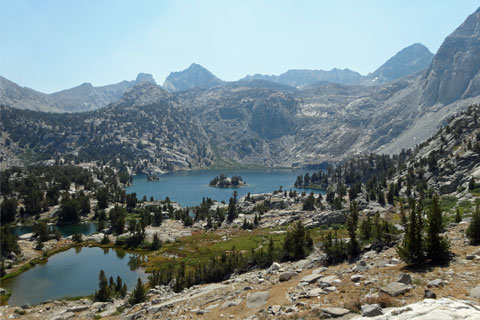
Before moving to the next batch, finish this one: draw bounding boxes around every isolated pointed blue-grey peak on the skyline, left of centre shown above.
[163,63,223,92]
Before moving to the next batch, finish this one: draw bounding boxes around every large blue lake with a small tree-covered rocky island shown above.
[127,169,323,206]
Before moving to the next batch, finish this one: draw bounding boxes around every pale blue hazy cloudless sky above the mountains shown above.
[0,0,479,93]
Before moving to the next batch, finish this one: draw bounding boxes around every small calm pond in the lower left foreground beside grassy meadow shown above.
[2,248,147,306]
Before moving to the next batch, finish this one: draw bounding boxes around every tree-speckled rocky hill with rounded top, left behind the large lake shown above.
[0,82,213,172]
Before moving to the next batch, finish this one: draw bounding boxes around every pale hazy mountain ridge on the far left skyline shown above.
[0,73,155,112]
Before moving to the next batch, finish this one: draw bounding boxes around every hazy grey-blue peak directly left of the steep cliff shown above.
[363,43,433,85]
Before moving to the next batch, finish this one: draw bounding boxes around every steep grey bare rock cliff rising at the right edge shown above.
[422,8,480,106]
